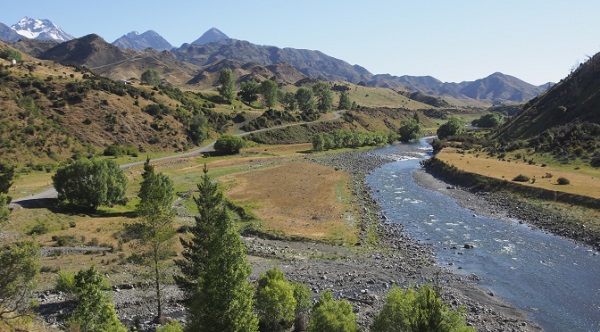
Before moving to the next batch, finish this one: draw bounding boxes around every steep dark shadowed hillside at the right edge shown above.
[496,53,600,167]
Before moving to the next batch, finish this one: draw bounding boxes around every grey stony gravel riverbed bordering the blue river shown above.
[38,152,541,331]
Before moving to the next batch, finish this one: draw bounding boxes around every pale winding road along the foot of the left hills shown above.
[9,111,344,208]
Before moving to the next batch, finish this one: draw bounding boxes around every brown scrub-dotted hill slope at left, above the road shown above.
[0,43,221,165]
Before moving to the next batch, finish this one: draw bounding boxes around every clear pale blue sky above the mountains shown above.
[0,0,600,85]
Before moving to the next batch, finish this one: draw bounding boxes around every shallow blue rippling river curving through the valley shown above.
[367,140,600,331]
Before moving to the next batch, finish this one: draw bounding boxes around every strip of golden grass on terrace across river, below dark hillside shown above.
[436,148,600,198]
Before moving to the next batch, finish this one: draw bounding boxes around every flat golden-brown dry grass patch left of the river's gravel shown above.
[221,162,357,243]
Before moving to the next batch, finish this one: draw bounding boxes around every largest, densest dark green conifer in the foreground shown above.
[175,165,258,332]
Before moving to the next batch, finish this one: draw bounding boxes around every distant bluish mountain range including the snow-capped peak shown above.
[0,18,552,104]
